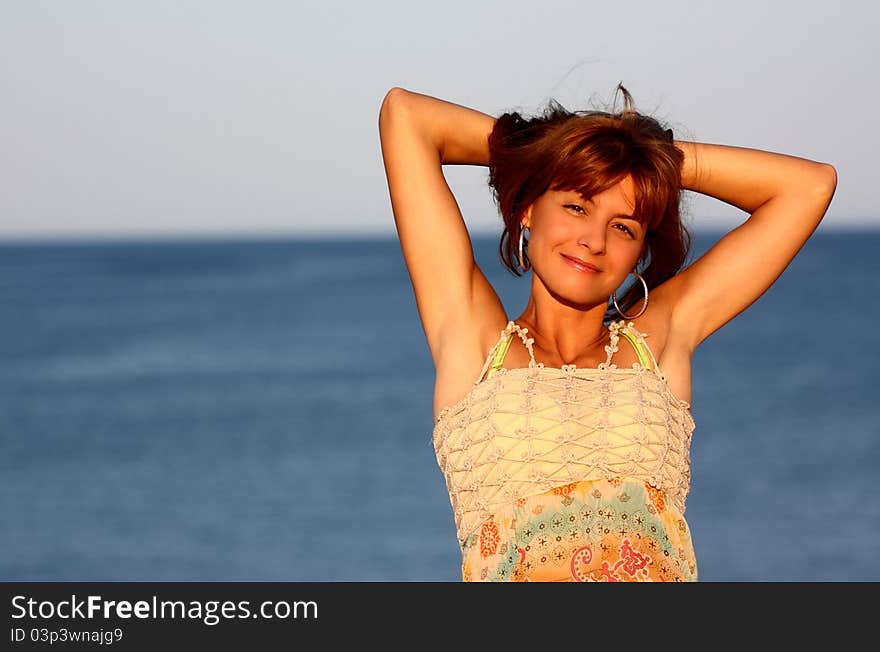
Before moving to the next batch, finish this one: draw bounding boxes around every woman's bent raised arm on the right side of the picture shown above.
[667,141,837,351]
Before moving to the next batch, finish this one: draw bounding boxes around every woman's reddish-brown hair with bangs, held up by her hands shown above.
[489,84,691,319]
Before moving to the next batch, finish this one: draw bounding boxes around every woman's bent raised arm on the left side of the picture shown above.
[379,88,504,367]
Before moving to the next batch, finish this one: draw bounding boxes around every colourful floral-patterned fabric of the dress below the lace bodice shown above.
[462,477,697,582]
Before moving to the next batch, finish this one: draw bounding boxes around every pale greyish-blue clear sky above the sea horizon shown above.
[0,0,880,239]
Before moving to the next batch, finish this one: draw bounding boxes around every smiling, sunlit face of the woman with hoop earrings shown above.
[523,176,645,306]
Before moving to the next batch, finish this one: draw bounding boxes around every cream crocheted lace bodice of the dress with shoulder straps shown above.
[433,321,695,542]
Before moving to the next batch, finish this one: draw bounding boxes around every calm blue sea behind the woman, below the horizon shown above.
[0,230,880,582]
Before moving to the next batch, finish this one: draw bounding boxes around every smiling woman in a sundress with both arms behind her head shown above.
[379,85,837,581]
